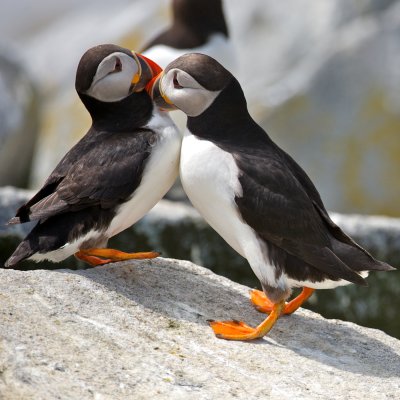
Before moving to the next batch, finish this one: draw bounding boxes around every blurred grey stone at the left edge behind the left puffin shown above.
[0,46,39,186]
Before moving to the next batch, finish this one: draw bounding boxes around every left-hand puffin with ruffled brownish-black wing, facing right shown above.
[5,44,181,267]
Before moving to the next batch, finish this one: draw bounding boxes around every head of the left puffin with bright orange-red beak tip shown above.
[75,44,161,103]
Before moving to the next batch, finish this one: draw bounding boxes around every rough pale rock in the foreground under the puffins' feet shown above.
[0,258,400,400]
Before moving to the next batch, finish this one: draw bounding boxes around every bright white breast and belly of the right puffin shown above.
[180,131,286,287]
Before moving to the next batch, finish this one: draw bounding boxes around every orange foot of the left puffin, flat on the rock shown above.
[75,249,160,266]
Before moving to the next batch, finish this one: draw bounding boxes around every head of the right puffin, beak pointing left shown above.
[146,53,234,117]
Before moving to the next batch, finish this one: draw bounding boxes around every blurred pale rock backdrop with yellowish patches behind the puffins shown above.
[0,0,400,216]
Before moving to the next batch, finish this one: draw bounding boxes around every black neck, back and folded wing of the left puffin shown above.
[16,91,155,222]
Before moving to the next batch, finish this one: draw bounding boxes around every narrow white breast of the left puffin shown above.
[107,109,182,237]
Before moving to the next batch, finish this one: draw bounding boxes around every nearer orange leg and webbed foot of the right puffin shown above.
[208,301,285,340]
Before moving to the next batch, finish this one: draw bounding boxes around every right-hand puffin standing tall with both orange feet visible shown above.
[146,53,394,340]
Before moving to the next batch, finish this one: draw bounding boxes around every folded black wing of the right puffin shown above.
[234,143,365,284]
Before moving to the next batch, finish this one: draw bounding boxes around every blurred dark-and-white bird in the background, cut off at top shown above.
[140,0,236,70]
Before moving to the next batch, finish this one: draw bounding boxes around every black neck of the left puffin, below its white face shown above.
[78,90,153,132]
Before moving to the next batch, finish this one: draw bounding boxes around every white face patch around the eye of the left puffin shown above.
[86,52,139,102]
